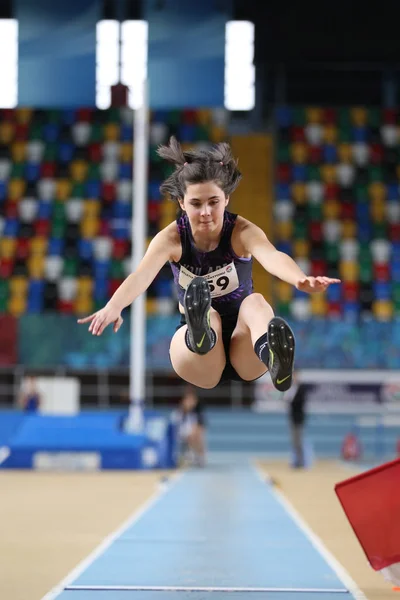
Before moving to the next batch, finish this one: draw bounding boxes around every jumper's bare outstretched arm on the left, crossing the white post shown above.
[78,226,174,335]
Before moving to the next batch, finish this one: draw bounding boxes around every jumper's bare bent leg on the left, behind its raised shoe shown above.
[169,308,225,389]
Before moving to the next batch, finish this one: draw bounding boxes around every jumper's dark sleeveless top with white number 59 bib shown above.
[170,211,253,316]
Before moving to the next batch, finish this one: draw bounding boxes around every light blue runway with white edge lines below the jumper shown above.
[43,465,364,600]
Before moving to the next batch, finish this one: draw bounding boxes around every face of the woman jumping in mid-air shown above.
[180,181,229,232]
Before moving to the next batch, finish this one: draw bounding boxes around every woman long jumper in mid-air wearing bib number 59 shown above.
[78,137,340,392]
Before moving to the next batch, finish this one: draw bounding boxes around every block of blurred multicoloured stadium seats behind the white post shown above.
[0,108,226,316]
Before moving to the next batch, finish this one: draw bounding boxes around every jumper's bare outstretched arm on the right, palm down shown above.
[240,222,340,293]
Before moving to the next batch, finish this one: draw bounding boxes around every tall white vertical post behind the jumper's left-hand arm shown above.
[126,81,149,432]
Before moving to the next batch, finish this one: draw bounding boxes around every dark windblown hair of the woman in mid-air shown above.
[157,136,242,201]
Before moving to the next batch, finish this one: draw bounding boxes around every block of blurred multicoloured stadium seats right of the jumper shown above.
[275,106,400,321]
